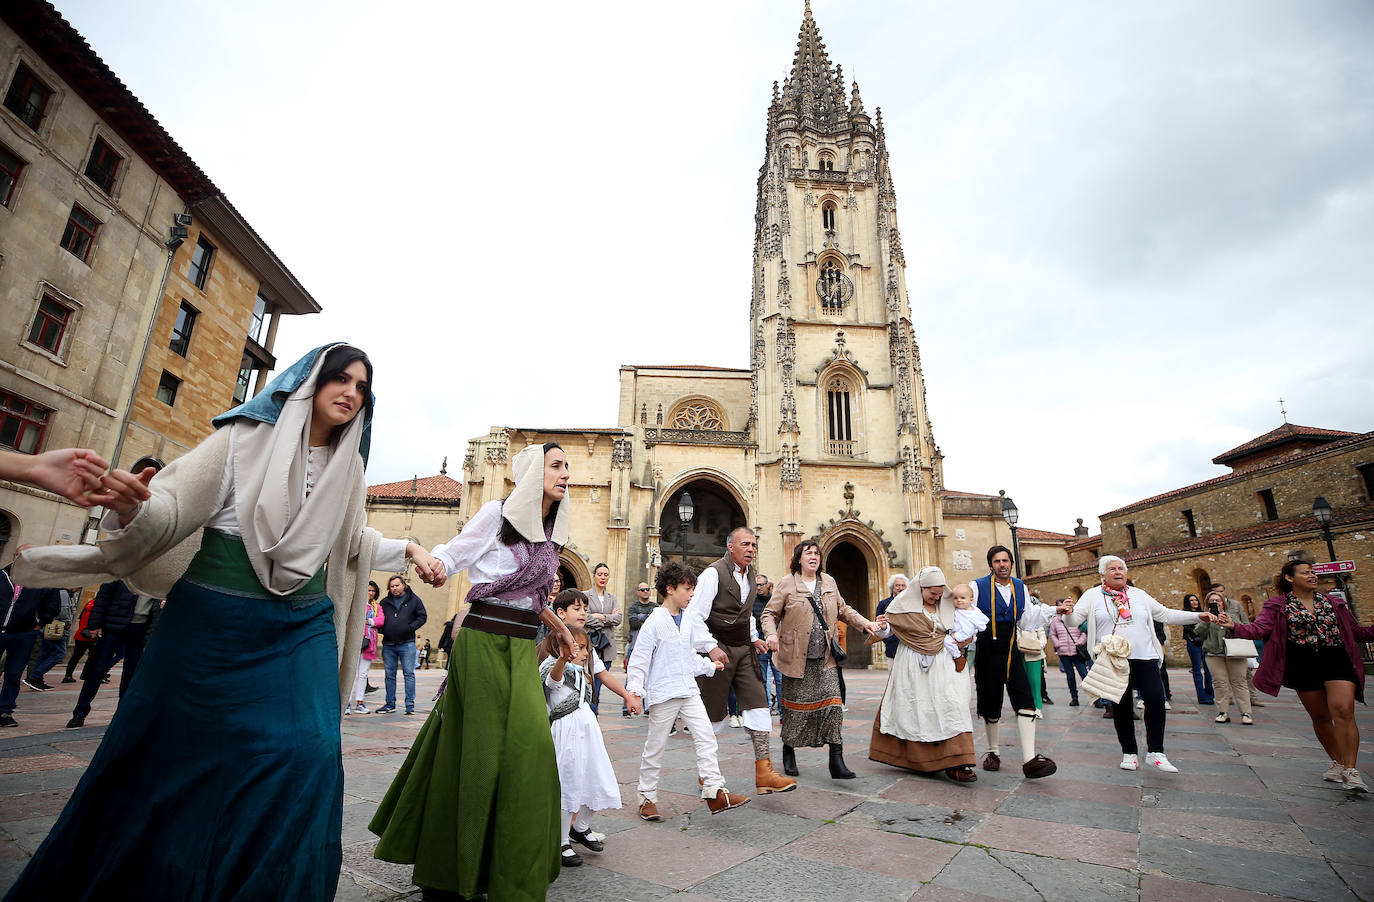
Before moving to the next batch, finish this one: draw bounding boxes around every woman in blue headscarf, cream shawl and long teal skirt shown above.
[5,344,442,901]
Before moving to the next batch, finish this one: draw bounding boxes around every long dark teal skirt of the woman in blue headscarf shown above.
[5,579,344,902]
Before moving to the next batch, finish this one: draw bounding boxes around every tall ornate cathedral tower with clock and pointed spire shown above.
[750,1,943,585]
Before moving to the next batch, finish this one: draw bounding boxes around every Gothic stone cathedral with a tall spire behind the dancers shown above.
[370,3,1073,666]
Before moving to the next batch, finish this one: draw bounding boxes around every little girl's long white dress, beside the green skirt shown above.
[539,656,620,811]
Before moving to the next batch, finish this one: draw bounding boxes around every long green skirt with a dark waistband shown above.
[368,630,563,902]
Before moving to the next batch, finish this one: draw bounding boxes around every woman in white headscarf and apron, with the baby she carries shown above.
[868,567,988,782]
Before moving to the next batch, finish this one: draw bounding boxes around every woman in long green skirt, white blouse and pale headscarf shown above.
[371,441,573,902]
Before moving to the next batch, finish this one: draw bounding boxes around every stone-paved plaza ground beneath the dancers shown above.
[0,670,1374,902]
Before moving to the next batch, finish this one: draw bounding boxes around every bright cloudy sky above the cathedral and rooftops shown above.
[50,0,1374,532]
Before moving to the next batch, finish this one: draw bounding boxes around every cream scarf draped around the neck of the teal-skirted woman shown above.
[229,352,365,595]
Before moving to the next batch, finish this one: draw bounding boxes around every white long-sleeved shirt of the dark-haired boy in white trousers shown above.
[625,602,716,705]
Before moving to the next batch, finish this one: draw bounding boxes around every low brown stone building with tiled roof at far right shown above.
[1028,424,1374,663]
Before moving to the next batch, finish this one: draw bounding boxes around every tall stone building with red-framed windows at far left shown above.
[0,0,320,554]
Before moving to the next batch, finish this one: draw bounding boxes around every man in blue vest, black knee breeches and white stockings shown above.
[973,545,1073,778]
